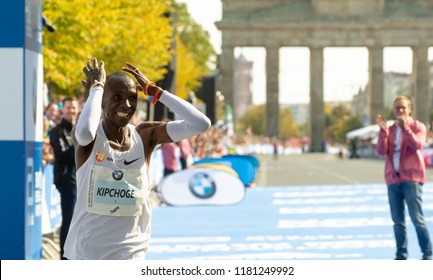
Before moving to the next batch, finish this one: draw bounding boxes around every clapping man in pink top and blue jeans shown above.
[376,96,432,260]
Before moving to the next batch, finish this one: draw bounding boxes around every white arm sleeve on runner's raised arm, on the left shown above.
[75,86,104,146]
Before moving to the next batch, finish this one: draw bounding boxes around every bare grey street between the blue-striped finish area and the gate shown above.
[251,153,433,186]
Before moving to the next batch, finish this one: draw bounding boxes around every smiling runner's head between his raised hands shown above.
[102,72,138,127]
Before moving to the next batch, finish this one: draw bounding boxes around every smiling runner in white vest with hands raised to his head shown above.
[65,58,210,260]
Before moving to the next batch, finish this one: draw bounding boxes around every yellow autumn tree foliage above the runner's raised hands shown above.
[43,0,216,103]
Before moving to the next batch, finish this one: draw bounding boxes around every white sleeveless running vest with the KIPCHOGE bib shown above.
[65,122,151,260]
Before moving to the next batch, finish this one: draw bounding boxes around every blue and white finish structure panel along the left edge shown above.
[0,0,43,260]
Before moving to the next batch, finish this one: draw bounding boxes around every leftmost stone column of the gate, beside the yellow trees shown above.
[219,46,236,116]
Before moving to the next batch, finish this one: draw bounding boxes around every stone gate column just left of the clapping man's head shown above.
[368,46,384,123]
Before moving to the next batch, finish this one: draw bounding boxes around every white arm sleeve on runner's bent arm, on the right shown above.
[159,90,211,142]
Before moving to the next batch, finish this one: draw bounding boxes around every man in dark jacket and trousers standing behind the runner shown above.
[50,97,78,259]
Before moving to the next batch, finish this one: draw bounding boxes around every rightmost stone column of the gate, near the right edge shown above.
[412,46,430,125]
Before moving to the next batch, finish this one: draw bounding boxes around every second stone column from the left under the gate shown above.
[266,46,280,137]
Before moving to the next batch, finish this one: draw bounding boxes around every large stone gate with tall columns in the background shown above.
[216,0,433,152]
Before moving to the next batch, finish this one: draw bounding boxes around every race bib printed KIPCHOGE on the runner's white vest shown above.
[87,165,143,216]
